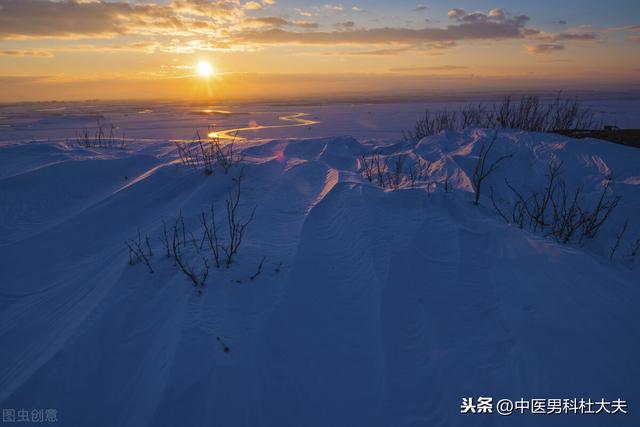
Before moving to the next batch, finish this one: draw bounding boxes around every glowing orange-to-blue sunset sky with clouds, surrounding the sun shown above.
[0,0,640,102]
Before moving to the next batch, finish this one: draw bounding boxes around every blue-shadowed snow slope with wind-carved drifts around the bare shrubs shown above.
[0,129,640,426]
